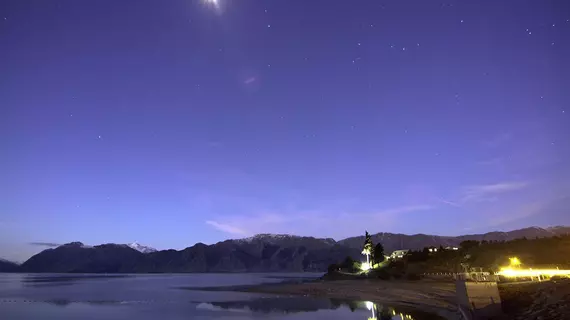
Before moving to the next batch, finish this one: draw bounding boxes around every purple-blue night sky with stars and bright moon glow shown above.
[0,0,570,261]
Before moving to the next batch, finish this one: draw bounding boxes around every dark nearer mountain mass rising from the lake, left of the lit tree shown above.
[20,235,352,273]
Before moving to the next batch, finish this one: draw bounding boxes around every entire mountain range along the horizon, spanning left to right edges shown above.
[0,227,570,273]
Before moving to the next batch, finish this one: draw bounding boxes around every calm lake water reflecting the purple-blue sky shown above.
[0,274,440,320]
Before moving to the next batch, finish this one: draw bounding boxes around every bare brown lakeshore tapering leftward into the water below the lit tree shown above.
[180,279,457,319]
